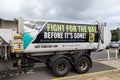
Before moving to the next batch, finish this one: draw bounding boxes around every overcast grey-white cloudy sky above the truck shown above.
[0,0,120,29]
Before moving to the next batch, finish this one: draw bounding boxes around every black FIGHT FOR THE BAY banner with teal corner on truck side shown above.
[23,20,99,50]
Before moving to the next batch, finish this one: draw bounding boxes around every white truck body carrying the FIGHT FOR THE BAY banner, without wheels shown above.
[0,19,111,53]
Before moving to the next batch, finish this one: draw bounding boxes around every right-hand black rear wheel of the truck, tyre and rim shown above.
[75,56,90,74]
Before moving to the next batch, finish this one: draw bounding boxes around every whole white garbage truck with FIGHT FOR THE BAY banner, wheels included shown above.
[0,17,111,77]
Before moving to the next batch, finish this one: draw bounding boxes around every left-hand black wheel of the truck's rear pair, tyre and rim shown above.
[52,58,71,77]
